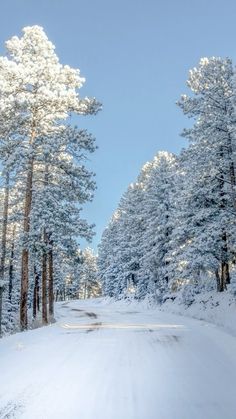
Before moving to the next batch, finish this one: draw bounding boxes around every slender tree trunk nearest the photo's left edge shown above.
[0,173,9,336]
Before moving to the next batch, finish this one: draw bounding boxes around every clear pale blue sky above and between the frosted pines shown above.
[0,0,236,247]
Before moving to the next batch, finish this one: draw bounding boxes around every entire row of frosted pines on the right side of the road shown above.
[99,57,236,305]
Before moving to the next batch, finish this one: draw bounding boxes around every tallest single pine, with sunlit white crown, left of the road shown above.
[0,26,101,330]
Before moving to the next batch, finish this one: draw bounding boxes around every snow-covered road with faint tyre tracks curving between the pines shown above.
[0,300,236,419]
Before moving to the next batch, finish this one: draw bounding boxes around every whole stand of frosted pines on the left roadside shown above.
[0,26,100,329]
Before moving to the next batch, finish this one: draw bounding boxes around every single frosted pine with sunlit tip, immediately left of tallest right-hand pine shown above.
[139,152,177,299]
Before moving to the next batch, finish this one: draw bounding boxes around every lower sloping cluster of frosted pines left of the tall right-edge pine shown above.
[98,152,176,298]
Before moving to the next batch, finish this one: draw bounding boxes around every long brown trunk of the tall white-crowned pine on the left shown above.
[20,159,34,330]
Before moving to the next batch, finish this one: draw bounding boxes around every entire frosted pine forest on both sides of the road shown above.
[0,26,236,342]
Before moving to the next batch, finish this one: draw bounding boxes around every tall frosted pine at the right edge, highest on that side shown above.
[179,57,236,291]
